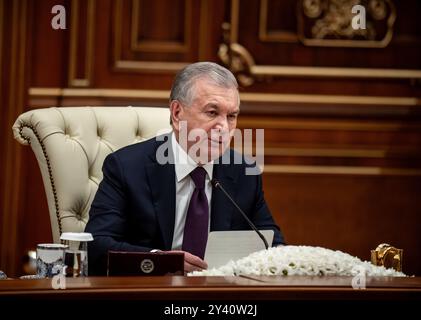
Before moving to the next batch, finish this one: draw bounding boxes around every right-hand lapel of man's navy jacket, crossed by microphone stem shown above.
[210,164,237,231]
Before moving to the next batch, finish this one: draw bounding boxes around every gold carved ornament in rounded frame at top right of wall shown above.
[297,0,396,48]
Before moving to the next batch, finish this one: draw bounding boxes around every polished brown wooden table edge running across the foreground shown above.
[0,276,421,300]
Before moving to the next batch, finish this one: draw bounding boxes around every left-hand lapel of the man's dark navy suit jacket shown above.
[147,135,175,250]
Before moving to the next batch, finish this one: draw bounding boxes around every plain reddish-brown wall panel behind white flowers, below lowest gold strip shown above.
[264,172,421,275]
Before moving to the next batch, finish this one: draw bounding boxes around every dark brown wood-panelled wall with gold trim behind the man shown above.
[0,0,421,275]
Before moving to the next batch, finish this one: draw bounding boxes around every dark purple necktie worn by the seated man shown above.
[182,167,209,259]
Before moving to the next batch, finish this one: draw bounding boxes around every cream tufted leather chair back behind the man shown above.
[13,107,170,243]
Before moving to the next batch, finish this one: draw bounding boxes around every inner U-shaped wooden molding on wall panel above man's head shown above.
[131,0,192,53]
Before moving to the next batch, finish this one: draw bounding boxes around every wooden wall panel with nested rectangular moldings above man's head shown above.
[90,0,223,90]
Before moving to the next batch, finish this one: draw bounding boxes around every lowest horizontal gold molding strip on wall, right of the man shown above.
[263,164,421,176]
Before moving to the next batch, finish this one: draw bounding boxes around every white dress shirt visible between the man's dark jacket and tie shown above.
[171,132,213,250]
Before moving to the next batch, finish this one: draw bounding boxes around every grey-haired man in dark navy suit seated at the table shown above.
[86,62,284,274]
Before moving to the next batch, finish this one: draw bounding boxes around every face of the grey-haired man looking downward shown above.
[170,79,240,163]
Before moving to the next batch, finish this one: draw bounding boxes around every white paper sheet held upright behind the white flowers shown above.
[205,230,274,269]
